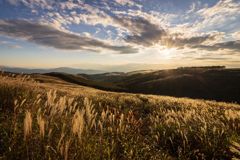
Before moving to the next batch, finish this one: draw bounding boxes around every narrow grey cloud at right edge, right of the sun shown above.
[190,40,240,53]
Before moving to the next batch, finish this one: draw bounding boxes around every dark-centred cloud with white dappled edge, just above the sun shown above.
[62,11,174,47]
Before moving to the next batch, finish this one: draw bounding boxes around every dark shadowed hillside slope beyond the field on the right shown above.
[80,68,240,103]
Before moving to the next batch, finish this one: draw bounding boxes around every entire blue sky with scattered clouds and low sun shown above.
[0,0,240,72]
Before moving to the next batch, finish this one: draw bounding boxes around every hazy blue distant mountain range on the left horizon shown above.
[2,66,106,74]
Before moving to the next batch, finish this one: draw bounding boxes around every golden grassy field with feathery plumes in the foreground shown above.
[0,69,240,160]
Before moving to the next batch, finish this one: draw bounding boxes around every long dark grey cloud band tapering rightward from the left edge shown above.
[0,20,138,54]
